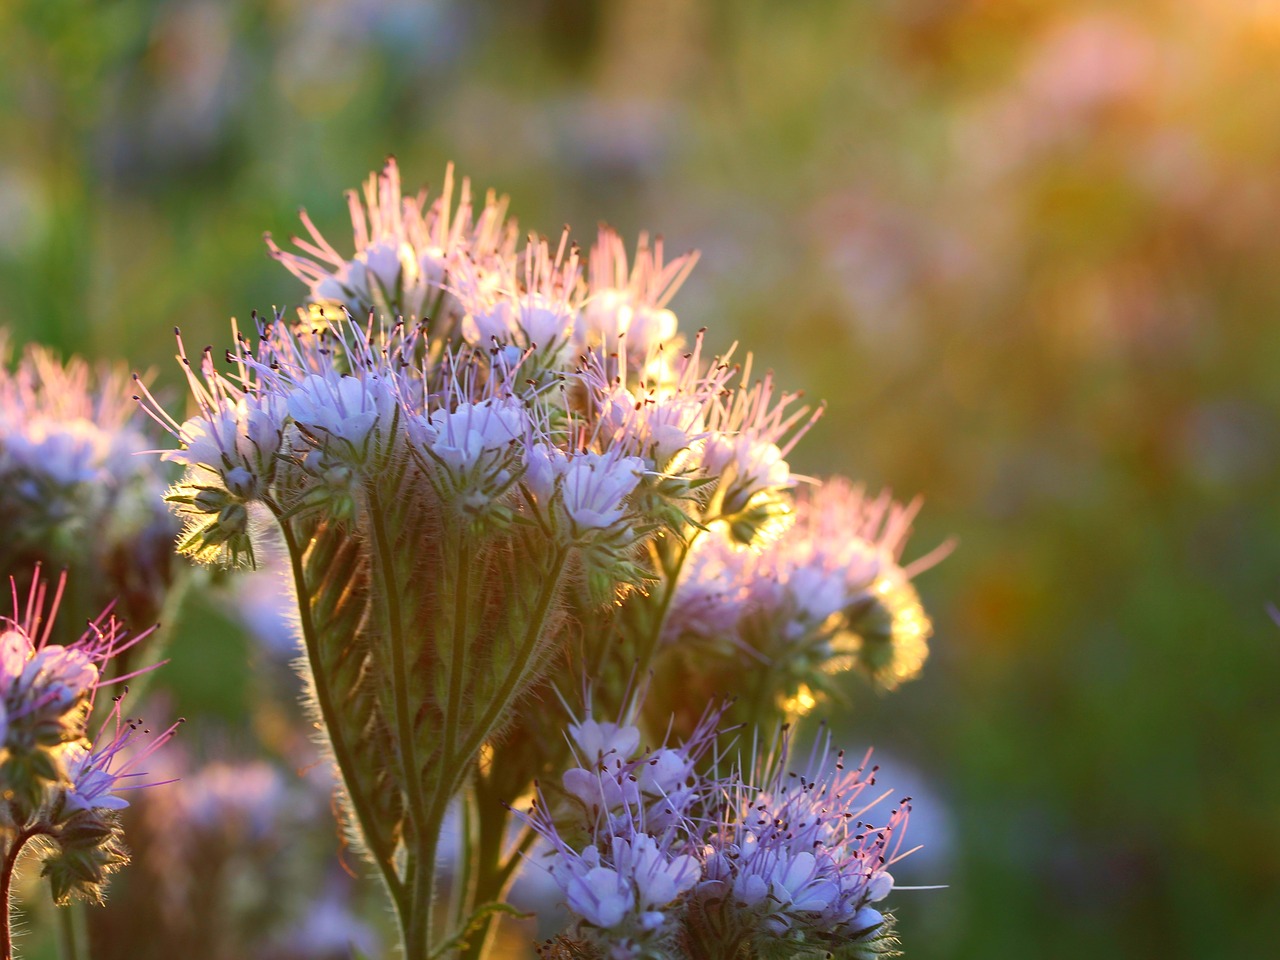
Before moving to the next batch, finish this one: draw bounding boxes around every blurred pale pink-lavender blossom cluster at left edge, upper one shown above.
[0,332,177,639]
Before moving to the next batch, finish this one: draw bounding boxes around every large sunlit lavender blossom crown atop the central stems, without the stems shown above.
[137,163,812,580]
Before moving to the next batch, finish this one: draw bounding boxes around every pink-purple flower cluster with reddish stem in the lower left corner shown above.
[0,571,177,915]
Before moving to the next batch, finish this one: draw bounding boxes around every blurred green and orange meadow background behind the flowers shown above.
[0,0,1280,960]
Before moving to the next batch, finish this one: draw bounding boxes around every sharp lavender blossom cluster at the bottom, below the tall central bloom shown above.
[521,712,911,960]
